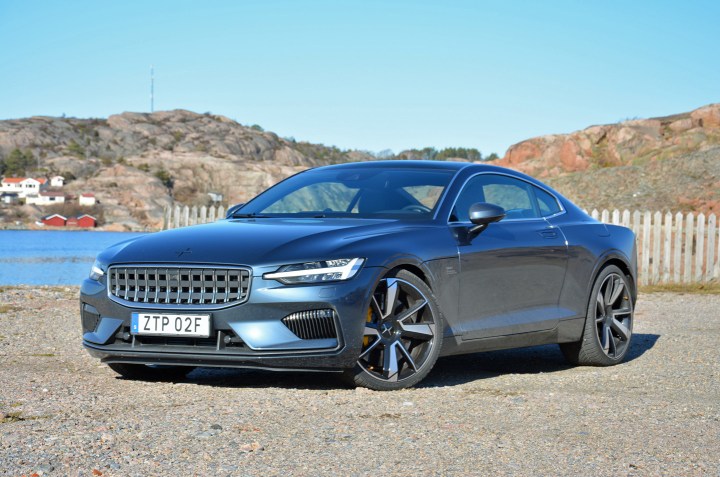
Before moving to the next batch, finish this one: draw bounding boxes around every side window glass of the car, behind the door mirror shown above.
[450,174,561,222]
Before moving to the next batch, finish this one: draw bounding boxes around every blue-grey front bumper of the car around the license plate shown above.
[80,267,384,371]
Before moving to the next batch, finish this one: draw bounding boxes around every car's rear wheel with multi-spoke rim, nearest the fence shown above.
[560,265,634,366]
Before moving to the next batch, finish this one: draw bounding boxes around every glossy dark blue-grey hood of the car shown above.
[98,218,430,267]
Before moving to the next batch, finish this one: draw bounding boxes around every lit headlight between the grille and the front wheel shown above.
[263,258,365,285]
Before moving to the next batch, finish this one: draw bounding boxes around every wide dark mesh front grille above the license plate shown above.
[108,266,250,305]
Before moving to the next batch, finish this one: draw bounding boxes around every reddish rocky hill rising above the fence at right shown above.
[495,104,720,214]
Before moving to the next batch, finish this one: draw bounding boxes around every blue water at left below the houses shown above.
[0,230,143,285]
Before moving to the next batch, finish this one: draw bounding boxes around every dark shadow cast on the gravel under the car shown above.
[179,333,660,391]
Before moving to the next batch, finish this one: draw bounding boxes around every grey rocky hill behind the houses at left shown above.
[0,110,371,230]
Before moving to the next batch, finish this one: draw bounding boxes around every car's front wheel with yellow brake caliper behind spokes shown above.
[344,270,443,391]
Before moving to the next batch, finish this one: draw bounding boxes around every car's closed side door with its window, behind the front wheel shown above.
[450,173,568,340]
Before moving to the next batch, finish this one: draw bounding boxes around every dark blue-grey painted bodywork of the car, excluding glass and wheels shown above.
[81,161,636,370]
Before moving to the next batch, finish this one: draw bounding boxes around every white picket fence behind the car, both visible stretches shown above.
[163,205,720,285]
